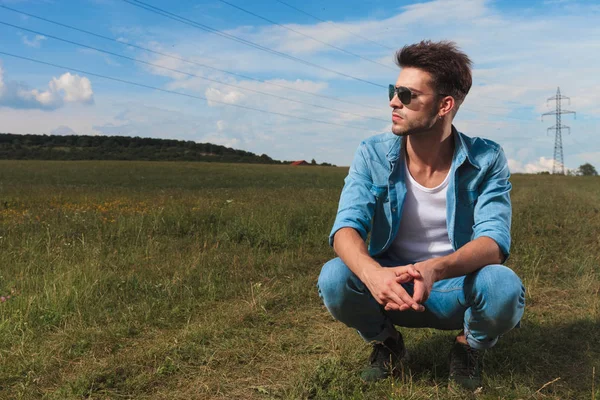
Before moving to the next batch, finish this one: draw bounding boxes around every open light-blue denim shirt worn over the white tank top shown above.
[329,126,512,258]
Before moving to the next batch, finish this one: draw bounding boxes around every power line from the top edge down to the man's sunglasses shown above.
[123,0,387,88]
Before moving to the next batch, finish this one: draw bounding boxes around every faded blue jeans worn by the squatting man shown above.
[318,258,525,349]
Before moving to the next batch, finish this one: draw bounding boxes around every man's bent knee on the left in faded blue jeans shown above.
[317,257,366,319]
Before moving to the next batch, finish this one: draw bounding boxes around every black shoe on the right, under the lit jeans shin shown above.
[449,342,484,390]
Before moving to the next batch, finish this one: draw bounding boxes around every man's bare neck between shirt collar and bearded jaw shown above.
[405,121,454,177]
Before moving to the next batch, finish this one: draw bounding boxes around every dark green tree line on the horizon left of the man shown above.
[0,133,330,165]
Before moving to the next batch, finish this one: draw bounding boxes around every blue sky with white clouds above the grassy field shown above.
[0,0,600,172]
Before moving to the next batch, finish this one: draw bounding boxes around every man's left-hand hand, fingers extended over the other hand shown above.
[362,265,425,311]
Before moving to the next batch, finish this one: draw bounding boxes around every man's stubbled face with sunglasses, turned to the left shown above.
[390,68,439,136]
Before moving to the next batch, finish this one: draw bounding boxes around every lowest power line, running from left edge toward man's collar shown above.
[0,51,382,131]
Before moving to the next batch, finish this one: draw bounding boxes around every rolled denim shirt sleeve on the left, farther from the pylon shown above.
[329,143,376,246]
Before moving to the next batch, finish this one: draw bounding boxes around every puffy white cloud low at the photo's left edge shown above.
[0,64,94,110]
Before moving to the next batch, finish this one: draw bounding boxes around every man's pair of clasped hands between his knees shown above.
[364,260,436,312]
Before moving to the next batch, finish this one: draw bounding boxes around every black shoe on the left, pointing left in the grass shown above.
[360,332,407,382]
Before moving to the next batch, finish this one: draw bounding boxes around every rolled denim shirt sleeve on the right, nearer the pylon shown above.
[473,148,512,259]
